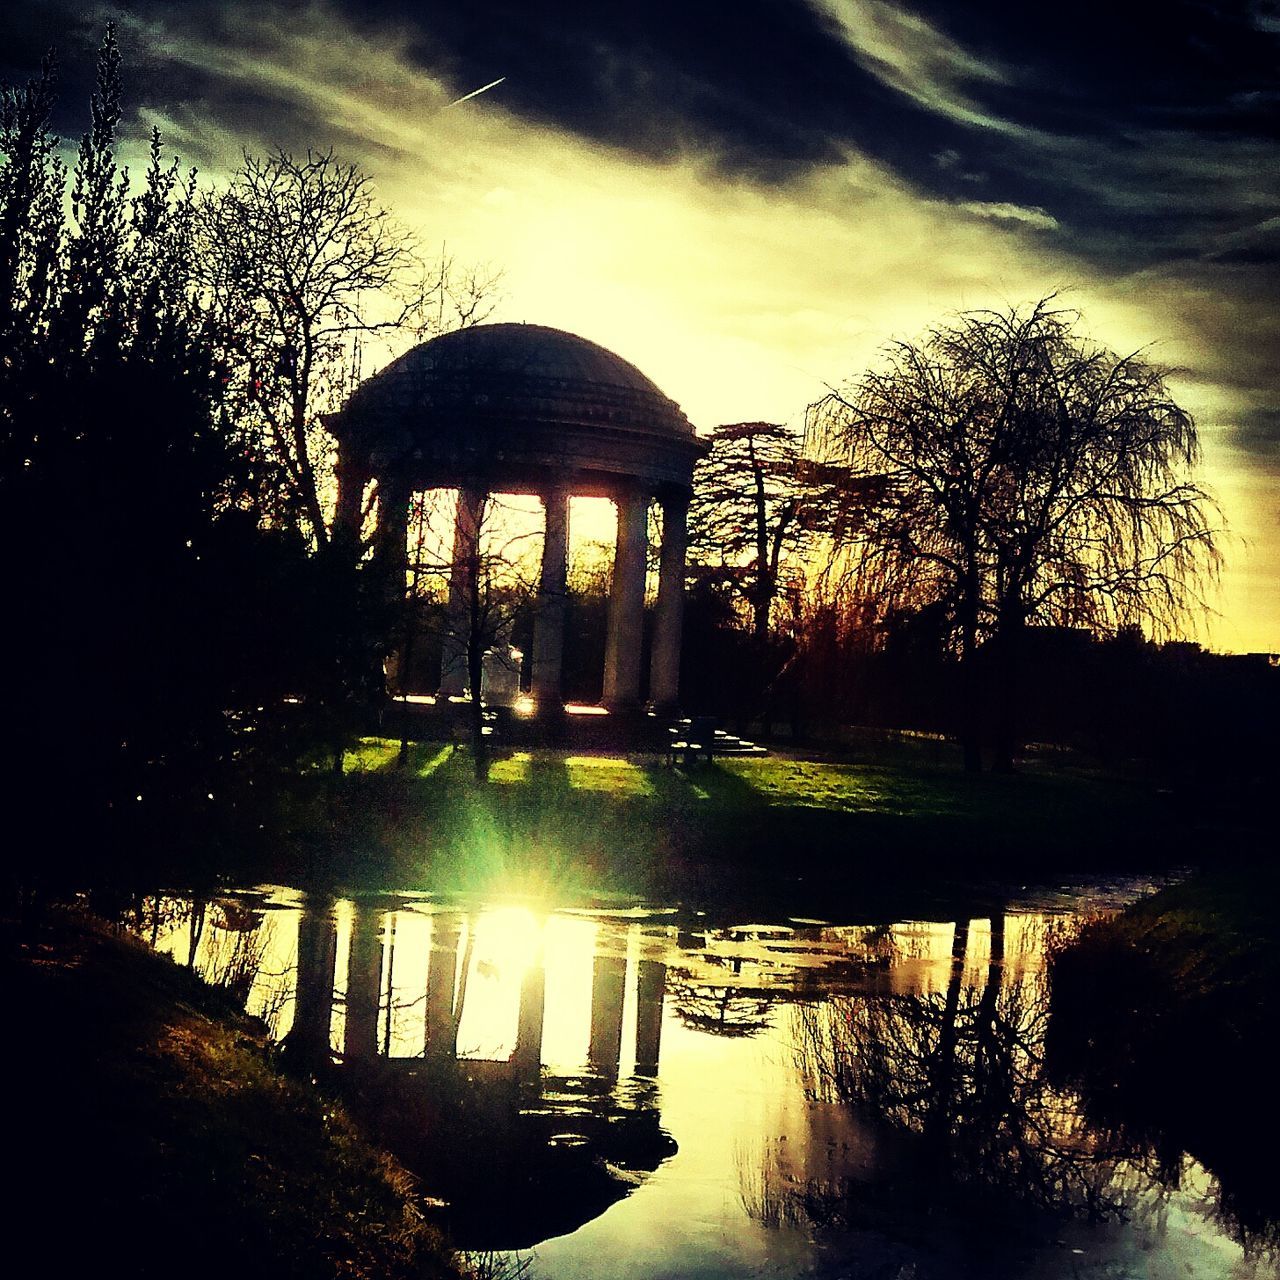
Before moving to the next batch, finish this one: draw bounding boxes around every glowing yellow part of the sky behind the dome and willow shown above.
[15,0,1280,650]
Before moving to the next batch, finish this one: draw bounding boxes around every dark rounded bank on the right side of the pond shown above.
[1047,865,1280,1256]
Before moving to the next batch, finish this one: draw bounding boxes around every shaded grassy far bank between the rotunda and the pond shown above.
[24,739,1223,914]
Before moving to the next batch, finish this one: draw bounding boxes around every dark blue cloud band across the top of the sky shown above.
[8,0,1280,269]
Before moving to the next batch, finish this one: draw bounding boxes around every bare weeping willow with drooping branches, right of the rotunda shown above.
[812,297,1221,769]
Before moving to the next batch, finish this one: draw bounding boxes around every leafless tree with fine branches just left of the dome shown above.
[200,150,498,545]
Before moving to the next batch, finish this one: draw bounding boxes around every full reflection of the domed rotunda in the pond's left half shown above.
[137,891,676,1249]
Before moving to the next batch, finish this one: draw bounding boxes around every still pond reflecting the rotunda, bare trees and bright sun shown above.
[133,882,1277,1280]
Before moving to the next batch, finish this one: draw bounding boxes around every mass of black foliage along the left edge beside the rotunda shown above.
[0,29,378,864]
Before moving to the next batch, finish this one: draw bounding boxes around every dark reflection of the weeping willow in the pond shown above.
[768,914,1161,1242]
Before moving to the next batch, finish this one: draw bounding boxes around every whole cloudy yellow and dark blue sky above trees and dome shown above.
[10,0,1280,650]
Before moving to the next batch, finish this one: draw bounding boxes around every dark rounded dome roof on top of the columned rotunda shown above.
[343,324,694,438]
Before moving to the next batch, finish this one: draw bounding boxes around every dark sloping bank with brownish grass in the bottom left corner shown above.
[0,909,461,1280]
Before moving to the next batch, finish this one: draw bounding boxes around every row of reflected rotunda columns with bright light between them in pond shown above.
[280,897,668,1085]
